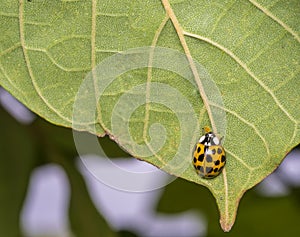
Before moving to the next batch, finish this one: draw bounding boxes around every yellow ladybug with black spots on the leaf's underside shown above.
[193,127,226,179]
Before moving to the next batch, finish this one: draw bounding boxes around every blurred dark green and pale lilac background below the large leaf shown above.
[0,88,300,237]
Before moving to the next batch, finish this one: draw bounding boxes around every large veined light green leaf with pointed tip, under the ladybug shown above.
[0,0,300,231]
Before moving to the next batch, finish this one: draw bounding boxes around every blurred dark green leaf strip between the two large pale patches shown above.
[32,120,115,237]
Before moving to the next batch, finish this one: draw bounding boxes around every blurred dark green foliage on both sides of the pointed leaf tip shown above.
[157,179,300,237]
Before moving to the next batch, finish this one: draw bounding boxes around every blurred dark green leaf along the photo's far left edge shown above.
[0,106,37,237]
